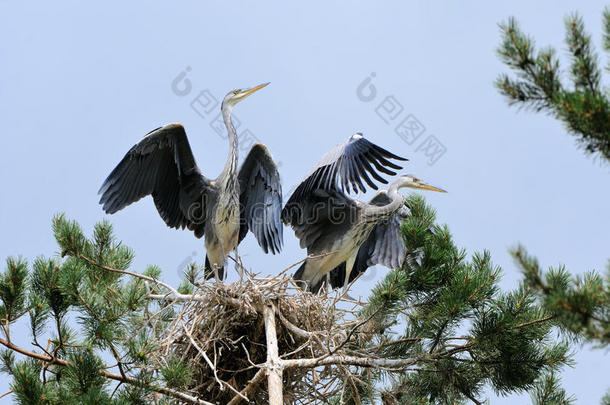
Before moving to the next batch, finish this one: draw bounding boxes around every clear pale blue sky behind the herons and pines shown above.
[0,0,610,404]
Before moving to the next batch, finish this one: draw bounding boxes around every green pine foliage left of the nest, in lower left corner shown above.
[0,215,178,405]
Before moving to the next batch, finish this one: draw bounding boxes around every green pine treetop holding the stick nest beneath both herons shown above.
[0,195,580,404]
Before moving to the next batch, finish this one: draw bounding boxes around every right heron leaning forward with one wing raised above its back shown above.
[282,134,444,292]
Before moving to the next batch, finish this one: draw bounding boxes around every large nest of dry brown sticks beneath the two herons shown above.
[159,266,362,404]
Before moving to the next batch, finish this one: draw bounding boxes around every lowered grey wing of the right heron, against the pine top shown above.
[330,192,409,288]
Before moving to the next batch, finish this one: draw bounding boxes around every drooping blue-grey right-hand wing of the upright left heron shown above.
[238,143,283,254]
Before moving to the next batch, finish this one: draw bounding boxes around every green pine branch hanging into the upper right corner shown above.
[495,8,610,161]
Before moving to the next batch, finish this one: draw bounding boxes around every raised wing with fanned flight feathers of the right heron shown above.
[282,134,407,224]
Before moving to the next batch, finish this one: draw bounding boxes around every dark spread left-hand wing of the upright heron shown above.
[98,124,213,238]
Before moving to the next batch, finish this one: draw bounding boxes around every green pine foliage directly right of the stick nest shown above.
[338,195,570,404]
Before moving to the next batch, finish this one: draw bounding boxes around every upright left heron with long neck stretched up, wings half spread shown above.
[99,83,283,280]
